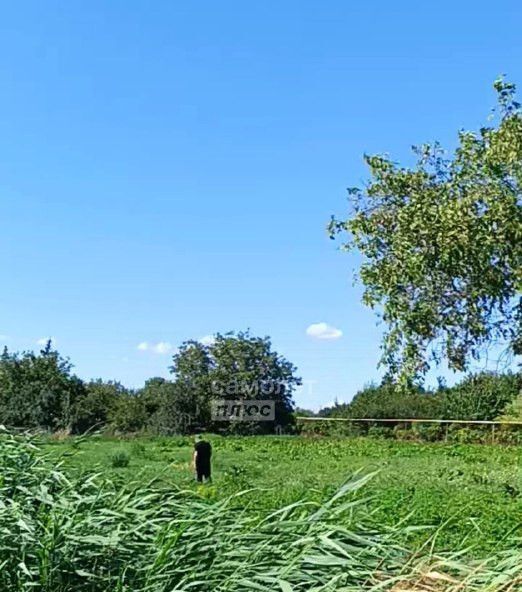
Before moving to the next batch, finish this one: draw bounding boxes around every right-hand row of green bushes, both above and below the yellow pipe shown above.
[298,372,522,444]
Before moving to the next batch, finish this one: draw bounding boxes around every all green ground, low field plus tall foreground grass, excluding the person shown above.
[0,432,522,592]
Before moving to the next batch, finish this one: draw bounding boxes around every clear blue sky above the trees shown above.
[0,0,522,407]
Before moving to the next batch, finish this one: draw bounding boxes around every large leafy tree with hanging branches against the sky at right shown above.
[329,79,522,382]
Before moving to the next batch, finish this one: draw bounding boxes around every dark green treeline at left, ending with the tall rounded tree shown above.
[0,332,301,434]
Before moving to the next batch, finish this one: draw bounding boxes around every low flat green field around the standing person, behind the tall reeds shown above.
[44,436,522,557]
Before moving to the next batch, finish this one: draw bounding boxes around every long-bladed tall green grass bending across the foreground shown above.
[0,435,522,592]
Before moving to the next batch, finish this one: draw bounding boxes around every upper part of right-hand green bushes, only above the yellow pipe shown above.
[319,372,522,421]
